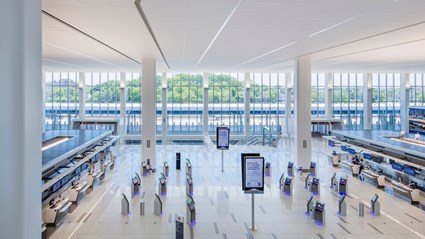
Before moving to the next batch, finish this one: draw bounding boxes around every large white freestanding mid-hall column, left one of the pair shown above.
[142,59,156,171]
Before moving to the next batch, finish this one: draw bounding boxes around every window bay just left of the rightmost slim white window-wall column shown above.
[372,73,400,130]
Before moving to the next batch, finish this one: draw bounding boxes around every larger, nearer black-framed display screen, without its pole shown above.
[242,156,264,192]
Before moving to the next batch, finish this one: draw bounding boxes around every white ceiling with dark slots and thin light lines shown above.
[42,0,425,72]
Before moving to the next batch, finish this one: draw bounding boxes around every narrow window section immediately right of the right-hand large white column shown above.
[311,73,326,117]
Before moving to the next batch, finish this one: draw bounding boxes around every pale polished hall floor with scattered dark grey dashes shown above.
[51,139,425,239]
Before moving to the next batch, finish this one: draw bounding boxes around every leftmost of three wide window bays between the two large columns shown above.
[167,73,203,135]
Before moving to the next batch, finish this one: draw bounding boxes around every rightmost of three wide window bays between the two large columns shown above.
[250,73,286,135]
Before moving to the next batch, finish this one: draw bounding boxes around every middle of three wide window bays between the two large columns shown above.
[208,73,245,135]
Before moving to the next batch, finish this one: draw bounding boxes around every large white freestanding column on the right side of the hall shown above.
[294,57,311,170]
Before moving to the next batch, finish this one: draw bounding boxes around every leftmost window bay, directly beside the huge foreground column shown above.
[44,72,80,130]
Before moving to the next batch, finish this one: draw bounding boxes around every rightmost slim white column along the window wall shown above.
[400,73,410,133]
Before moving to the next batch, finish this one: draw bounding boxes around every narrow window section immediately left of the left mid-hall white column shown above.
[125,72,142,134]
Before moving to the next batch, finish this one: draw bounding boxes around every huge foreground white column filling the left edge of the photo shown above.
[0,0,43,239]
